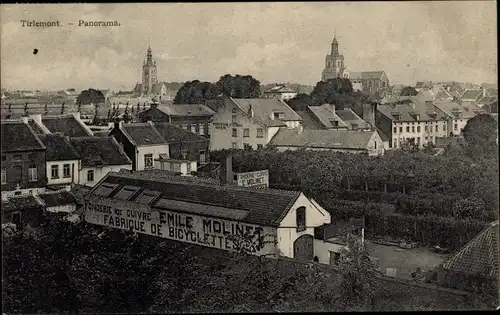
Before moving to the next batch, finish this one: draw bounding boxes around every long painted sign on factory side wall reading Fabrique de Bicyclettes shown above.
[84,196,276,250]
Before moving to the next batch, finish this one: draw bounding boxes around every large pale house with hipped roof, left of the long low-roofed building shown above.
[210,98,302,150]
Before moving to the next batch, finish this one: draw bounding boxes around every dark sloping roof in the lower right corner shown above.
[442,221,499,278]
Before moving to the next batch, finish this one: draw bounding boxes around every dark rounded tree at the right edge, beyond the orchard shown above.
[462,114,498,156]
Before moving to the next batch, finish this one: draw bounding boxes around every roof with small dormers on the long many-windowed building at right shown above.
[377,101,448,121]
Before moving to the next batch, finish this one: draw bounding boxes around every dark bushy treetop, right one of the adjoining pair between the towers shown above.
[215,74,260,98]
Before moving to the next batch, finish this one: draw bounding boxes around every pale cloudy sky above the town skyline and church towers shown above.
[0,1,498,90]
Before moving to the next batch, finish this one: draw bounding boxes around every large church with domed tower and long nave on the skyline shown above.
[321,36,390,93]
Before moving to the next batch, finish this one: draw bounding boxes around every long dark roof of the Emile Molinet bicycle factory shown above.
[91,172,300,226]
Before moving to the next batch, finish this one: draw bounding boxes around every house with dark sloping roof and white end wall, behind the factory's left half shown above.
[110,122,169,171]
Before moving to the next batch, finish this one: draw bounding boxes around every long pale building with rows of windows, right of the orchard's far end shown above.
[375,101,449,148]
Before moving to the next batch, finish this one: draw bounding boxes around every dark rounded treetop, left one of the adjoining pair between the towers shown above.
[174,80,218,104]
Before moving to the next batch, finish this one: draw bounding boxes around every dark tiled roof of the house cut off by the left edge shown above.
[1,120,45,152]
